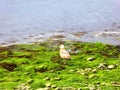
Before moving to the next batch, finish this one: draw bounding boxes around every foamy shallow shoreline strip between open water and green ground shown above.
[0,30,120,46]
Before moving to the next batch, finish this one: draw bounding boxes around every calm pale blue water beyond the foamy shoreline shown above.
[0,0,120,44]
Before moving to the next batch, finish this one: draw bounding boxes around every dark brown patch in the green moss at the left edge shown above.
[0,62,17,71]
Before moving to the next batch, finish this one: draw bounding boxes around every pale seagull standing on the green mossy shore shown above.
[59,44,71,60]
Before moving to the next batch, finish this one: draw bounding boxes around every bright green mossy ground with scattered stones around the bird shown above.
[0,41,120,90]
